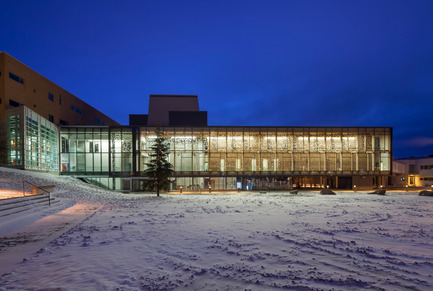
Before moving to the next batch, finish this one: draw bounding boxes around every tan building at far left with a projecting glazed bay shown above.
[0,52,119,172]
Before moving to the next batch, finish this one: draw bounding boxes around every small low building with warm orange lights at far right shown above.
[393,155,433,187]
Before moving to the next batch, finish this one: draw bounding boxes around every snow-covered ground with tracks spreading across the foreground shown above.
[0,169,433,290]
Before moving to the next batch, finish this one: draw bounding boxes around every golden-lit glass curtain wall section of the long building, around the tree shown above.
[139,127,392,189]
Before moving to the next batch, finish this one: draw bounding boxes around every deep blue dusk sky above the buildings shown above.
[0,0,433,158]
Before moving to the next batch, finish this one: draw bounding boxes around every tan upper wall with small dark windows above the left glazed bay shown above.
[0,52,118,125]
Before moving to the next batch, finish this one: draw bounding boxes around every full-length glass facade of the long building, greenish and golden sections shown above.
[60,126,392,190]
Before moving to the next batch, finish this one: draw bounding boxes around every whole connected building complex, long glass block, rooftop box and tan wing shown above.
[1,54,392,191]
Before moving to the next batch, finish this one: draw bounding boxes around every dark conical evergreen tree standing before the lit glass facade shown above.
[145,127,173,197]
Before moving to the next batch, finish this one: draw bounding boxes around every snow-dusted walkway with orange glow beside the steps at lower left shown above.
[0,202,101,276]
